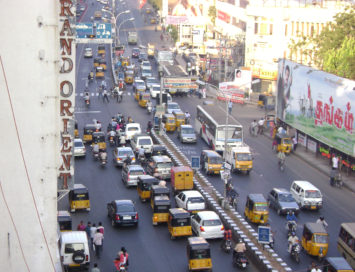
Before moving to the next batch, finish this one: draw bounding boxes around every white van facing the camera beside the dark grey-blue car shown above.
[290,180,323,210]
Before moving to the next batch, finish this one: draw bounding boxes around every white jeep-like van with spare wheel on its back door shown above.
[59,231,90,271]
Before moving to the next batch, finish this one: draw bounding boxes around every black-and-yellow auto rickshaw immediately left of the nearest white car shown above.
[168,208,192,240]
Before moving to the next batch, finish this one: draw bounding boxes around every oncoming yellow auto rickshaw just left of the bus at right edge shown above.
[302,223,329,259]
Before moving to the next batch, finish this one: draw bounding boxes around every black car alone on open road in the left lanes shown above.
[107,199,138,227]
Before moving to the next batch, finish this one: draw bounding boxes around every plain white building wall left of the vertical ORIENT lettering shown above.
[0,0,60,272]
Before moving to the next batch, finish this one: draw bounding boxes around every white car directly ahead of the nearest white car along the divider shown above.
[175,190,206,212]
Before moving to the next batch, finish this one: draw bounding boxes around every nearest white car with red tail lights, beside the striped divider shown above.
[191,211,224,239]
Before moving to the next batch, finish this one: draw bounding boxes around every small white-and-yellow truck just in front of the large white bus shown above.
[226,143,253,174]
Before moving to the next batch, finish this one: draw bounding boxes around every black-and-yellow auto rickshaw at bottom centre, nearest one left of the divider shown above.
[187,237,212,271]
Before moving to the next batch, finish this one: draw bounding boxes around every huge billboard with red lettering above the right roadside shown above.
[276,59,355,157]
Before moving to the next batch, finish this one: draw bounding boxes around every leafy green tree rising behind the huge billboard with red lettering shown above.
[289,6,355,79]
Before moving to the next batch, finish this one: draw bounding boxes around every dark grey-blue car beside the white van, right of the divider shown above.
[267,188,300,215]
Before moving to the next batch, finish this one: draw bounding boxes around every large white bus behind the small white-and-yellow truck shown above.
[195,104,243,153]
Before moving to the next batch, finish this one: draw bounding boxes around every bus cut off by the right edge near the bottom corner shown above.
[338,222,355,269]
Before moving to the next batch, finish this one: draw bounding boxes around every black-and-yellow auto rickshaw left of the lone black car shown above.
[69,184,90,212]
